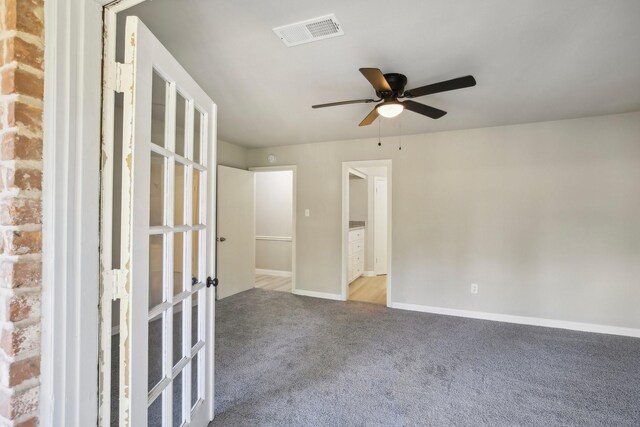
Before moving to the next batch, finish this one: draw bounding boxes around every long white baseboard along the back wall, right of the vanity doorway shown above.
[391,302,640,338]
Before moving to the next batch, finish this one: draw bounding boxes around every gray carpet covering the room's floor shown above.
[212,289,640,427]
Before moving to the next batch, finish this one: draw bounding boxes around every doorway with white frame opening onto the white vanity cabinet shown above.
[342,160,391,306]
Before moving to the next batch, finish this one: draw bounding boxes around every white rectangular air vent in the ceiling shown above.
[273,14,344,47]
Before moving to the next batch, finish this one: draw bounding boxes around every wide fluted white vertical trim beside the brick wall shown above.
[39,0,107,427]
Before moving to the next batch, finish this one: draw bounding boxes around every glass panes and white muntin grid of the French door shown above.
[147,69,207,425]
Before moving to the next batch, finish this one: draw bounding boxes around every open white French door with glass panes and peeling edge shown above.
[119,17,216,427]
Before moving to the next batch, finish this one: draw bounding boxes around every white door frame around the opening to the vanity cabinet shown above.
[341,159,393,307]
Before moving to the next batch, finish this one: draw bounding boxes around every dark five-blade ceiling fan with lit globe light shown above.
[312,68,476,126]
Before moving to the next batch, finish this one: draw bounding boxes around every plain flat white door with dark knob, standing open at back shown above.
[217,166,256,298]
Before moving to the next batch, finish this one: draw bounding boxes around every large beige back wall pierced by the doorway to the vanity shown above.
[248,112,640,328]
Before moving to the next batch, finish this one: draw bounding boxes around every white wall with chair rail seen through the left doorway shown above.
[255,171,293,272]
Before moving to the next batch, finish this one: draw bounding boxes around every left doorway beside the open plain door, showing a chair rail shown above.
[251,166,296,292]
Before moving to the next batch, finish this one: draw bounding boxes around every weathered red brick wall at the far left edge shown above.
[0,0,44,427]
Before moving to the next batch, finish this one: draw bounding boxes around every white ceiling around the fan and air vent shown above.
[127,0,640,147]
